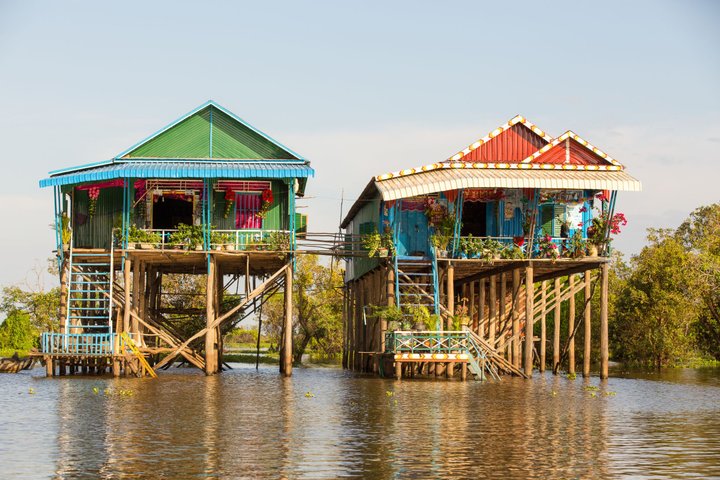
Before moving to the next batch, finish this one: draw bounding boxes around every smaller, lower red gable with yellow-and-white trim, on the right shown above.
[522,130,623,169]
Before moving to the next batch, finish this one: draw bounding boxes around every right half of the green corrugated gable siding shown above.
[212,109,296,160]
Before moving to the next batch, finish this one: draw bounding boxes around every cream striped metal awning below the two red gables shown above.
[375,169,642,201]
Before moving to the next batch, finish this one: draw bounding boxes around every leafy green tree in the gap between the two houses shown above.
[263,255,343,363]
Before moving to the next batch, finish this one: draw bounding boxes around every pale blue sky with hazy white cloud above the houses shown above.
[0,0,720,285]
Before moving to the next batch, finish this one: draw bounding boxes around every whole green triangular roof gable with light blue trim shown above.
[115,101,302,160]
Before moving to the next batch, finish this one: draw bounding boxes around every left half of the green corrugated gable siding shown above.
[123,108,210,158]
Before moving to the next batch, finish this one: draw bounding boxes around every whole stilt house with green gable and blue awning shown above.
[40,101,313,375]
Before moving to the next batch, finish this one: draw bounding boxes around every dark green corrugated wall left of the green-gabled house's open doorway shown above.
[72,188,123,249]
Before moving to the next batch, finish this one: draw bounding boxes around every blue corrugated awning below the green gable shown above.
[40,160,315,187]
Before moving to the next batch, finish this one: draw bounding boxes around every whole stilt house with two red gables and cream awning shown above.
[341,116,641,378]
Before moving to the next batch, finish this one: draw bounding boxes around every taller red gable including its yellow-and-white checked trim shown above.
[446,115,552,163]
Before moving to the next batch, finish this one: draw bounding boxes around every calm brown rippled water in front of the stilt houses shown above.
[0,365,720,479]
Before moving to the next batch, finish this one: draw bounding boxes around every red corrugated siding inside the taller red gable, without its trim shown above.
[462,123,548,163]
